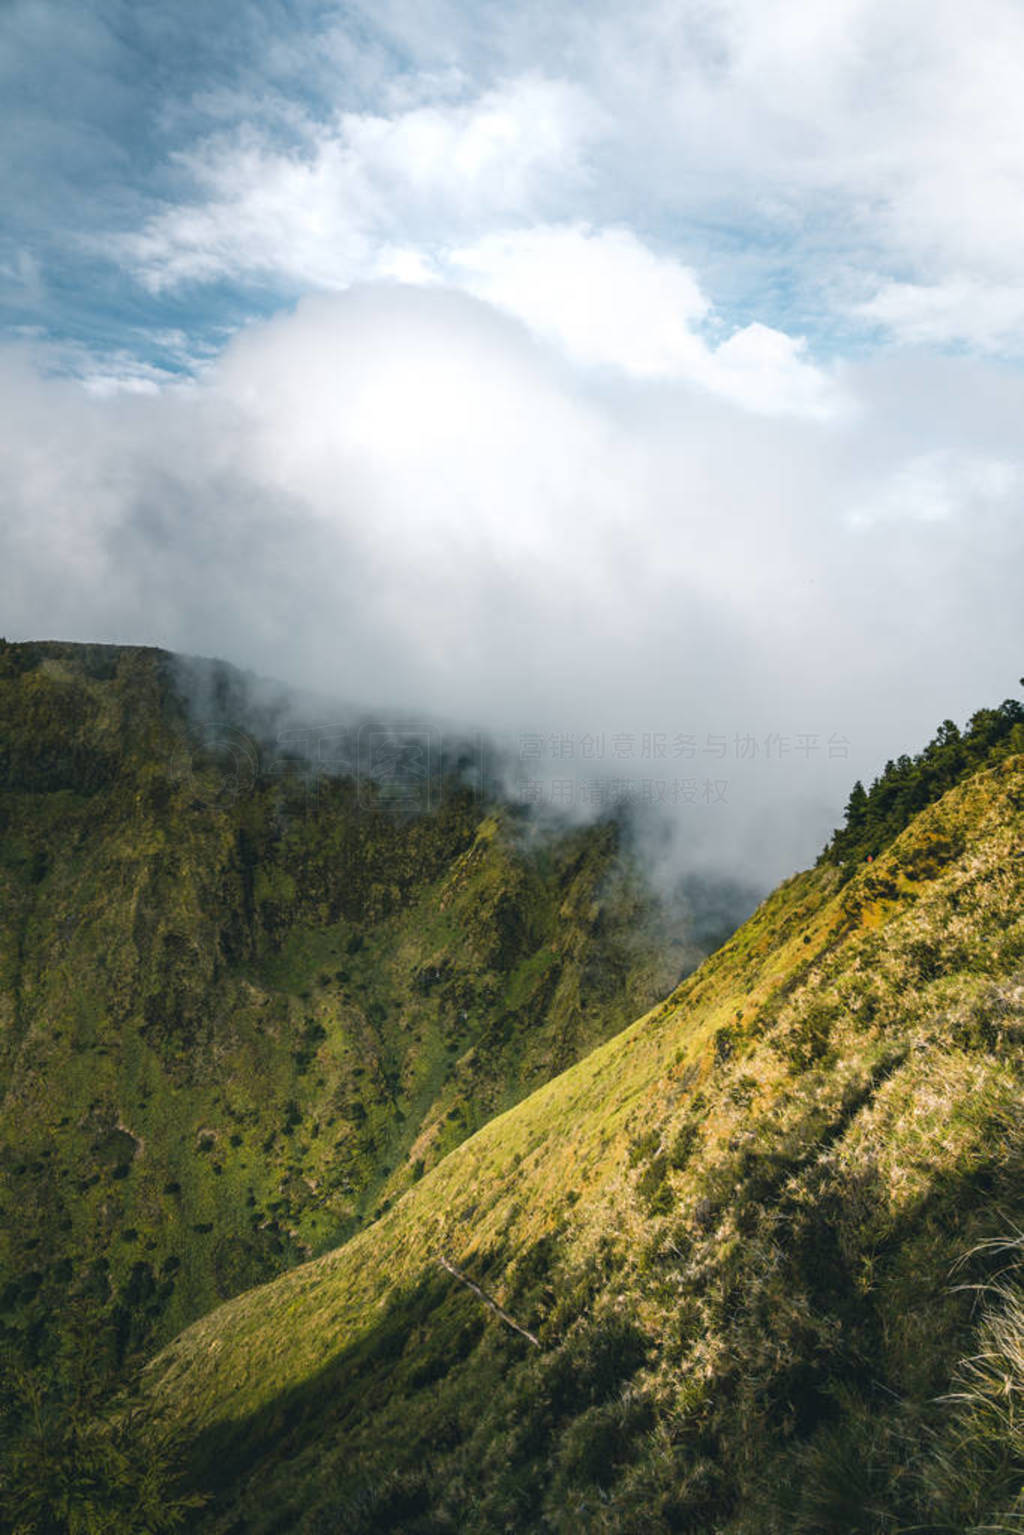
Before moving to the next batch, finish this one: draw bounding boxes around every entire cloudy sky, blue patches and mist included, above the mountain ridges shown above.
[0,0,1024,880]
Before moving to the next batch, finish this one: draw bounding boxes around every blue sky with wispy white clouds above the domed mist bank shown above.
[8,0,1024,391]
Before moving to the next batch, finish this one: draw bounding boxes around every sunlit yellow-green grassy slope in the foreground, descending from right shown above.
[152,757,1024,1535]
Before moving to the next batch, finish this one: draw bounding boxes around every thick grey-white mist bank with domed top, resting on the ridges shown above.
[0,286,1024,886]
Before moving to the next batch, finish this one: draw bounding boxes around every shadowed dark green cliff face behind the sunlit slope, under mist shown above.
[0,645,700,1375]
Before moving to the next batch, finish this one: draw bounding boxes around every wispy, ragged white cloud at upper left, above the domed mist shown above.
[122,75,594,290]
